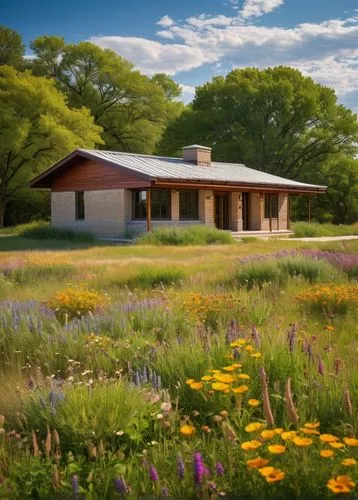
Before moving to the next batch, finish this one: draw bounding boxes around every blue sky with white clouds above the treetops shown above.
[0,0,358,112]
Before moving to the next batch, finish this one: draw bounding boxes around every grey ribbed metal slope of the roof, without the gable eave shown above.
[78,149,325,189]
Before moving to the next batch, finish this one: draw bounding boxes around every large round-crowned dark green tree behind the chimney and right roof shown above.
[158,67,358,181]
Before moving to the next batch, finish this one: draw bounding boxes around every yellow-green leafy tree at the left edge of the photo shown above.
[0,66,102,227]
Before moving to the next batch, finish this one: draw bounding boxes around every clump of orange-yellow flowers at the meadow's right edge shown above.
[297,284,358,316]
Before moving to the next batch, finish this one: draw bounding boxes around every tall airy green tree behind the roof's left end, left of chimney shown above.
[31,36,182,153]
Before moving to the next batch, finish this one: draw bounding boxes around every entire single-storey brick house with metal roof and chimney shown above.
[31,144,326,236]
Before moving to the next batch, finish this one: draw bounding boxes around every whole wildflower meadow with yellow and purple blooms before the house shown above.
[0,234,358,499]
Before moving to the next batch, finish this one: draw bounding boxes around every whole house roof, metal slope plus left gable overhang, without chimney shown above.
[31,149,326,192]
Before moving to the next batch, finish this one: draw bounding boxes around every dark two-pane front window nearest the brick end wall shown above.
[133,189,171,220]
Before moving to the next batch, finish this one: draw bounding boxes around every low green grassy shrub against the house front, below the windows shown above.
[136,225,235,245]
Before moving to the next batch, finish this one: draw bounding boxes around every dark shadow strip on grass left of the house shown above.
[0,235,110,252]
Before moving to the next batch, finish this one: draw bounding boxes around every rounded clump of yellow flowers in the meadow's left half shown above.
[48,288,109,321]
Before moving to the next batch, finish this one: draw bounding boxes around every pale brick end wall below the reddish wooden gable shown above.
[51,189,126,236]
